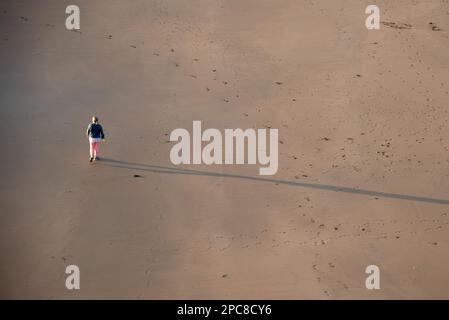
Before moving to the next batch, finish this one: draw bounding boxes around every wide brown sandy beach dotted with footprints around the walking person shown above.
[0,0,449,299]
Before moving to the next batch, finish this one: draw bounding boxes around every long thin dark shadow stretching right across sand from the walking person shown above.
[100,158,449,205]
